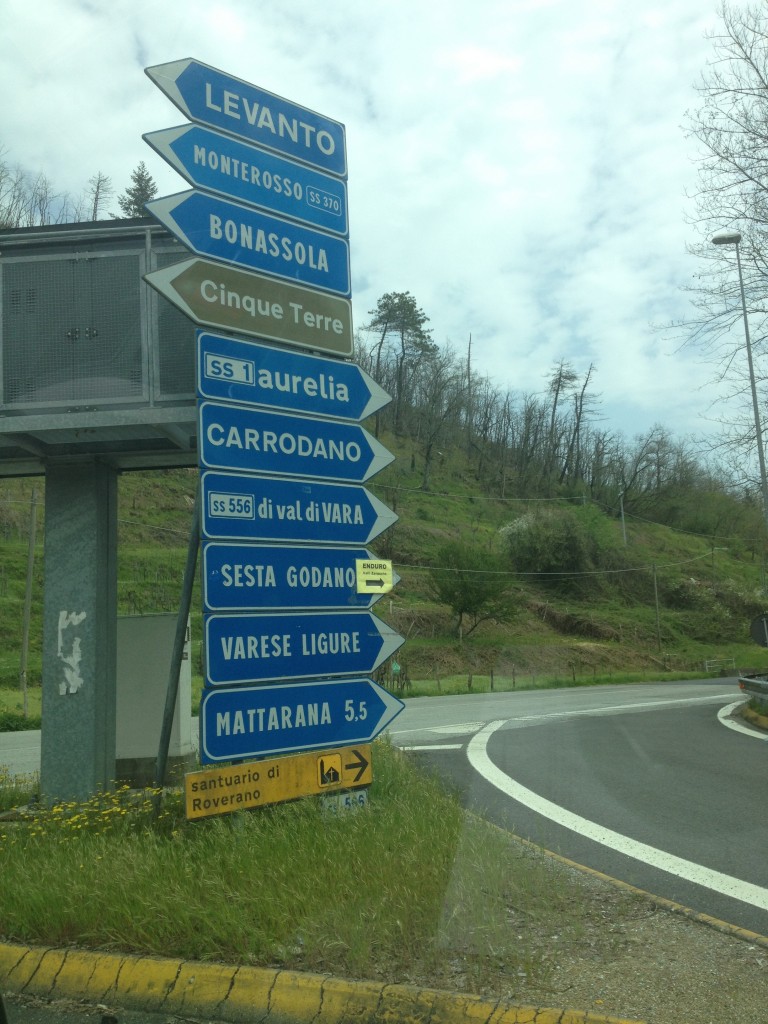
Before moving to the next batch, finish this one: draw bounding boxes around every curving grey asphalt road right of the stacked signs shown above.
[390,680,768,935]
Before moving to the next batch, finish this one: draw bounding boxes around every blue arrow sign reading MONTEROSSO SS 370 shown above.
[142,125,348,234]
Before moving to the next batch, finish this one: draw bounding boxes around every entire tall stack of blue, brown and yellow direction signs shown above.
[144,59,404,817]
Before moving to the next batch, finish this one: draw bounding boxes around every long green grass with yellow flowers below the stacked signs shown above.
[0,742,606,985]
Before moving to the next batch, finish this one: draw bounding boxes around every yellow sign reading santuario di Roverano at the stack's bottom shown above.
[184,743,373,819]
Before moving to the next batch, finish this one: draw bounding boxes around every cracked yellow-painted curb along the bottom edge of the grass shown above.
[0,943,651,1024]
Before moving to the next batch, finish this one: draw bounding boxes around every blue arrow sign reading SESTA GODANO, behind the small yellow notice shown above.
[203,543,399,611]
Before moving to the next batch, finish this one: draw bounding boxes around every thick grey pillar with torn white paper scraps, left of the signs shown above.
[40,459,117,802]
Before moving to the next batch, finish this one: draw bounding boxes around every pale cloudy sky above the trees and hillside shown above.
[0,0,737,436]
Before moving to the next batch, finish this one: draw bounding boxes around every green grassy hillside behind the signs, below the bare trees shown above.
[0,436,768,720]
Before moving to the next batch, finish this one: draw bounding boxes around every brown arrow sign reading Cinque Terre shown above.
[144,259,353,356]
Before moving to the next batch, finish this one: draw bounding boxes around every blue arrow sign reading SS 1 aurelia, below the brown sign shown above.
[198,331,391,422]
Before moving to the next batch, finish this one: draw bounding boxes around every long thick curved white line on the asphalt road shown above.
[467,720,768,910]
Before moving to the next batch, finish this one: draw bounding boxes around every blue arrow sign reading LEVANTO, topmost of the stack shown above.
[144,58,347,177]
